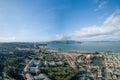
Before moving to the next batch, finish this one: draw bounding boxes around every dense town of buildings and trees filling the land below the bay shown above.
[0,43,120,80]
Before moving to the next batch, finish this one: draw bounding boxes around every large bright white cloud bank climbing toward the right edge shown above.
[74,10,120,39]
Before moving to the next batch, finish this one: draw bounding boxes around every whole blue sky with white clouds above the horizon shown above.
[0,0,120,42]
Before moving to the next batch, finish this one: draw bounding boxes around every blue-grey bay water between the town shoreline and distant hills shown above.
[48,41,120,53]
